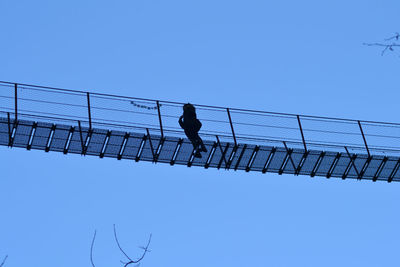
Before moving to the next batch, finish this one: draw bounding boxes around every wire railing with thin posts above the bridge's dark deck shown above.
[0,82,400,156]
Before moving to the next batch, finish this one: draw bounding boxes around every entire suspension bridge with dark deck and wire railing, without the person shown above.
[0,81,400,182]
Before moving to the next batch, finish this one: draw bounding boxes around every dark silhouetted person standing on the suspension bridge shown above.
[179,103,207,158]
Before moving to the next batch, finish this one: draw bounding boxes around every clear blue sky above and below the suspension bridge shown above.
[0,0,400,267]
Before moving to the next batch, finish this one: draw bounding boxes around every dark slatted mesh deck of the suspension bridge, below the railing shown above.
[0,117,400,182]
